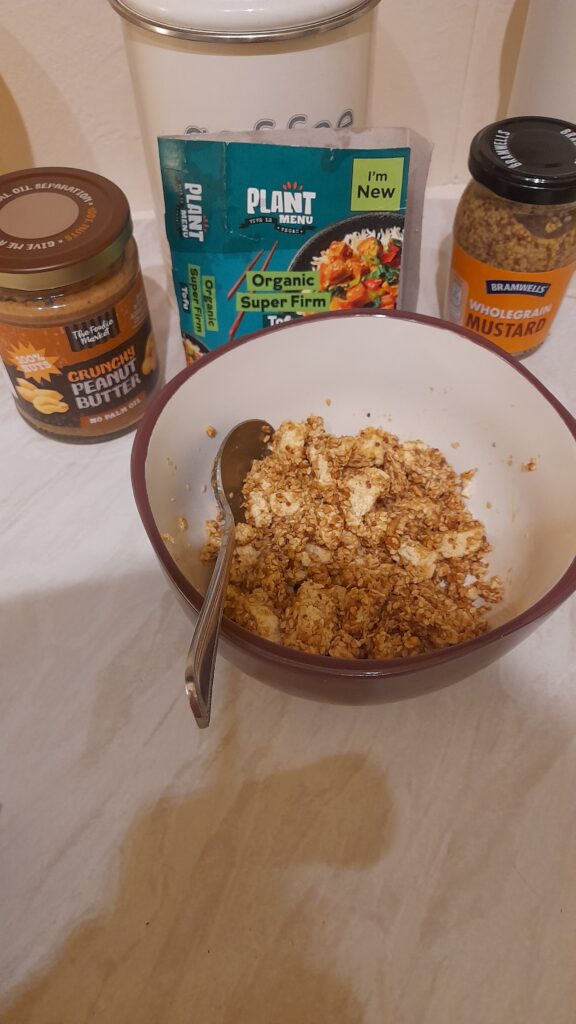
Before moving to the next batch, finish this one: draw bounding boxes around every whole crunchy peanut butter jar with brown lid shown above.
[0,167,158,442]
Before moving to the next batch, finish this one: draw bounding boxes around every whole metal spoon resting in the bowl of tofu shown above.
[186,420,274,729]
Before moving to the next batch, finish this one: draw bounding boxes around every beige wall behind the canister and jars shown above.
[0,0,528,213]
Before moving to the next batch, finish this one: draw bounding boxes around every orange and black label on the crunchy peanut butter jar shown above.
[0,275,157,437]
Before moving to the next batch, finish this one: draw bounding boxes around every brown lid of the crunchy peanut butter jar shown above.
[0,167,132,292]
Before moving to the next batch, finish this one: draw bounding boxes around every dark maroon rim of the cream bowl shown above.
[130,309,576,681]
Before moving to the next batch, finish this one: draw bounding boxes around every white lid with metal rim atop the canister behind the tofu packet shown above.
[110,0,379,42]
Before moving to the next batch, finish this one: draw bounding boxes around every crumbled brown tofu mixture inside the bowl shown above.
[202,416,502,658]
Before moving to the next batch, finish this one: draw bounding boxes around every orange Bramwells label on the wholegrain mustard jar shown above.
[447,245,576,354]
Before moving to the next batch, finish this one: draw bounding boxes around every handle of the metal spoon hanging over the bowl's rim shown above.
[186,514,236,729]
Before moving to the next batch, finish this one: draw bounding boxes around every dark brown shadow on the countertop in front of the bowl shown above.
[2,751,390,1024]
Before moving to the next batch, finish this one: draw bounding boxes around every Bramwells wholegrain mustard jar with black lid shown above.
[446,117,576,356]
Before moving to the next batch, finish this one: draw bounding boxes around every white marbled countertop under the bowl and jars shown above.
[0,193,576,1024]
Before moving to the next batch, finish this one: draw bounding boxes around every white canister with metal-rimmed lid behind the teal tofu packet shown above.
[110,0,378,211]
